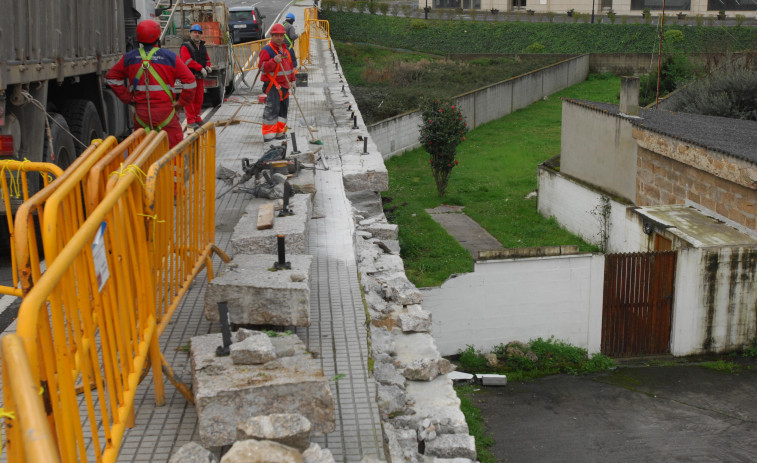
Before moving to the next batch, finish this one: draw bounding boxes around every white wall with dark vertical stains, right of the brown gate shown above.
[671,246,757,355]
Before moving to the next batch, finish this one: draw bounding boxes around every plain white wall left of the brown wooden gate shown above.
[421,254,604,355]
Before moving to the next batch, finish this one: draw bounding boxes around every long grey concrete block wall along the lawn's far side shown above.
[368,55,589,159]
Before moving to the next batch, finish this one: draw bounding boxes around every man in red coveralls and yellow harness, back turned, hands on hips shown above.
[105,19,197,147]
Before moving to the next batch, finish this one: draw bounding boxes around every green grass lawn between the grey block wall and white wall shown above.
[383,76,620,287]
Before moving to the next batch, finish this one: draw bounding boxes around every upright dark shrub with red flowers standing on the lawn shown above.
[418,99,468,198]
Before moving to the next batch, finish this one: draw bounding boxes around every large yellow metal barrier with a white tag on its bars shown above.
[3,165,159,462]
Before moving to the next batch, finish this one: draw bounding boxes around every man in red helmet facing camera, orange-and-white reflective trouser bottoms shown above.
[258,24,296,142]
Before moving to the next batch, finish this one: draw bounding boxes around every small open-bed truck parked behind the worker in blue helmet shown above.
[161,2,234,106]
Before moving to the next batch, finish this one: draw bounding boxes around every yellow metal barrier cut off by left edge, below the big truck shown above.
[0,161,63,296]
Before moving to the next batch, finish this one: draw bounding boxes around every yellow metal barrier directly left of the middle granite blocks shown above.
[144,123,230,335]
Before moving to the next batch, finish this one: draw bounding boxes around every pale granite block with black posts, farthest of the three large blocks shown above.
[231,194,313,254]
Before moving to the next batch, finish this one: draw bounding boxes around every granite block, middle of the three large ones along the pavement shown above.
[205,254,313,326]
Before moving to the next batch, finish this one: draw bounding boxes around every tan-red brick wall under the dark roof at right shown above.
[636,147,757,230]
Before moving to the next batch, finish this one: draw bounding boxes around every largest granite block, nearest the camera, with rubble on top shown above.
[191,331,336,448]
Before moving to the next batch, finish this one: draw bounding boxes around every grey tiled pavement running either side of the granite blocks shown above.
[2,6,384,462]
